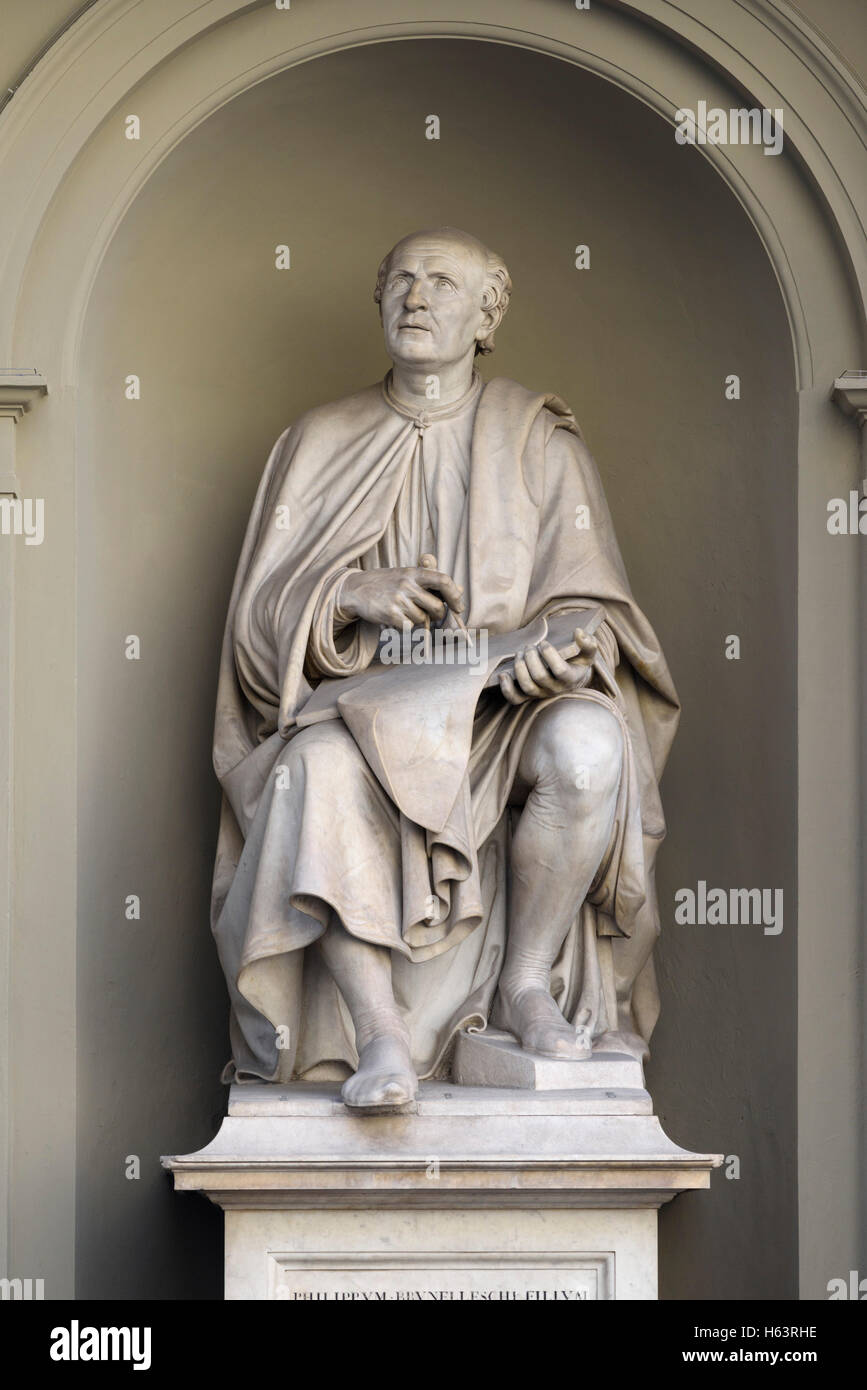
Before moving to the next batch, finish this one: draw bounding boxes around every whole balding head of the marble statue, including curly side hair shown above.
[374,227,511,370]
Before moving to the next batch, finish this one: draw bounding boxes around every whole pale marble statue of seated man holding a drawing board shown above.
[213,228,678,1113]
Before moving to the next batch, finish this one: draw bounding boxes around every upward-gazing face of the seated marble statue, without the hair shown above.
[381,236,489,371]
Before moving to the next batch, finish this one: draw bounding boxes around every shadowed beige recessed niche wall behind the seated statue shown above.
[76,40,796,1298]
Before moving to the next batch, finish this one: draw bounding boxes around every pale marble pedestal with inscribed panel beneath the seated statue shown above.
[163,1054,721,1301]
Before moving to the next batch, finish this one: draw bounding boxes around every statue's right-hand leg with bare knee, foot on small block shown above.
[496,701,624,1061]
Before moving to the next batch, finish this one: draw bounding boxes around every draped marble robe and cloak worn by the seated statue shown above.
[211,378,679,1081]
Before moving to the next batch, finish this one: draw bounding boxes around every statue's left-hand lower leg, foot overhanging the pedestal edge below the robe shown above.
[318,917,418,1109]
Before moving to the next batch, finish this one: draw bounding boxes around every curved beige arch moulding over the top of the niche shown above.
[0,0,867,386]
